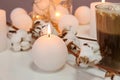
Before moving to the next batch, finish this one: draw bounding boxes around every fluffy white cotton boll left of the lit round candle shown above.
[10,29,32,51]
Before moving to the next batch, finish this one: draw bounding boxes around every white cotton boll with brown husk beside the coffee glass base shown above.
[79,43,102,67]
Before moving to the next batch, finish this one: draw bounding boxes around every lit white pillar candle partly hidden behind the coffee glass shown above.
[90,0,108,39]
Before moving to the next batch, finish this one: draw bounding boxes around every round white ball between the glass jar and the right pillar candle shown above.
[75,6,90,25]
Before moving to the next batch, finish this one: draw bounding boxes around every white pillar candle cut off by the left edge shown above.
[0,9,7,52]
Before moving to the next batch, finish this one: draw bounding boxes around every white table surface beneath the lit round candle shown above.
[0,27,104,80]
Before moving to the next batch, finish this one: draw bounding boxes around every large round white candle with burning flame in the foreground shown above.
[32,25,68,71]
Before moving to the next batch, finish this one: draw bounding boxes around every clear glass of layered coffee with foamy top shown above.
[96,3,120,70]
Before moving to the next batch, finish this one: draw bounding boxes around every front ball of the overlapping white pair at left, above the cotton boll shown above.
[12,14,32,31]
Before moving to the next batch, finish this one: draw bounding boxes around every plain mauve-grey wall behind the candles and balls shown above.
[0,0,120,21]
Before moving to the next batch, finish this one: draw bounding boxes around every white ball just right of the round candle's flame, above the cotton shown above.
[58,15,79,31]
